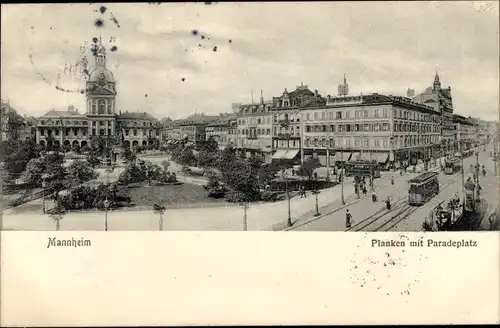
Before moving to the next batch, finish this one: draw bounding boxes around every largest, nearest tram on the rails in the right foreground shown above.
[408,172,439,206]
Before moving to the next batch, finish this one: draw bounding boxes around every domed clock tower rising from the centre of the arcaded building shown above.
[86,40,117,137]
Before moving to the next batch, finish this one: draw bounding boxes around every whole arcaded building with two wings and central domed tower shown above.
[36,40,162,154]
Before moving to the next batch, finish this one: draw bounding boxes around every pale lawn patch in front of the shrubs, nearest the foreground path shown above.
[128,183,225,206]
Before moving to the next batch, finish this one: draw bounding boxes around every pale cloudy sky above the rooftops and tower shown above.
[1,1,500,120]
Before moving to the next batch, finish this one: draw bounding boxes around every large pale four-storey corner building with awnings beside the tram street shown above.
[302,94,441,167]
